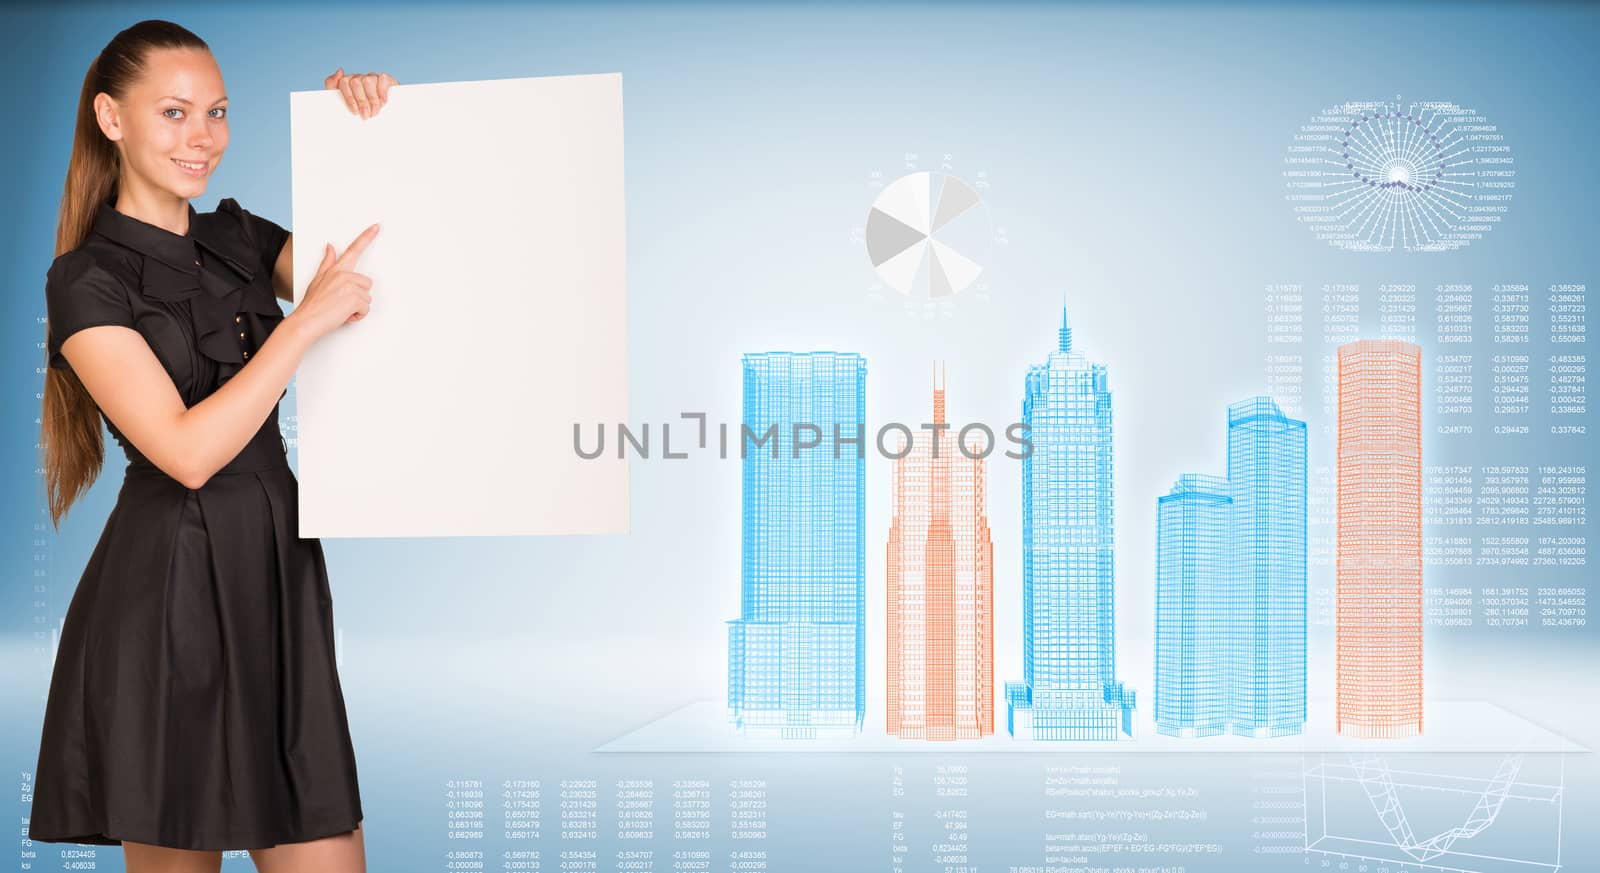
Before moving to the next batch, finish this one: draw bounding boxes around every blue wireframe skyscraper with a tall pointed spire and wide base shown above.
[1005,312,1134,740]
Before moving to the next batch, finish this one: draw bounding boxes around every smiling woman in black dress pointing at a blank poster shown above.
[29,21,395,873]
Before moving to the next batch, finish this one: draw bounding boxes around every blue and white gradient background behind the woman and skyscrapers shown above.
[0,3,1600,871]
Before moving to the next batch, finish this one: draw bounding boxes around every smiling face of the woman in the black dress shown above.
[94,48,227,200]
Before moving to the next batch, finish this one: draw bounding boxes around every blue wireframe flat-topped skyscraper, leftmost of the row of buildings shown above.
[728,352,867,739]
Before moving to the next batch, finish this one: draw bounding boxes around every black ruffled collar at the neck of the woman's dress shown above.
[93,192,283,365]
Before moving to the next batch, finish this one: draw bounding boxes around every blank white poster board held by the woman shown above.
[290,74,629,537]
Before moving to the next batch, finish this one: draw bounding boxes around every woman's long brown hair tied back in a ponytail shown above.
[38,19,211,528]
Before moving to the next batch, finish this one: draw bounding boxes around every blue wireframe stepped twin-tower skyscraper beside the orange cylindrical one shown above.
[1155,397,1306,737]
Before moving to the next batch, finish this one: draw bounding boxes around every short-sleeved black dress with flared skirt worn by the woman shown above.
[29,198,362,849]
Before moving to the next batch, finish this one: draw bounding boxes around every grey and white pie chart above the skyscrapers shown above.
[864,171,994,299]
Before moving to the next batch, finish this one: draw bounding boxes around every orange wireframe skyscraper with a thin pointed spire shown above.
[886,362,995,740]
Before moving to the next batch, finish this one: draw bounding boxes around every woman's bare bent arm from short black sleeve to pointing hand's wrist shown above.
[61,312,314,489]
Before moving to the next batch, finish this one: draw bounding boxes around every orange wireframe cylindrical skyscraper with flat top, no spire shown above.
[1336,339,1422,737]
